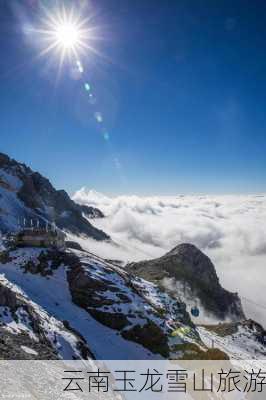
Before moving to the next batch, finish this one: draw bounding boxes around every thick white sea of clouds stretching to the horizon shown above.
[73,188,266,326]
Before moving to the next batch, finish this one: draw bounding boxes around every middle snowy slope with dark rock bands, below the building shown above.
[0,248,206,359]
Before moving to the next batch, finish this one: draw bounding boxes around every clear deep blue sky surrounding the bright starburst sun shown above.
[0,0,266,194]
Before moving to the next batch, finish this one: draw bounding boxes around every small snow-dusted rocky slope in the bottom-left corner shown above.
[0,274,92,359]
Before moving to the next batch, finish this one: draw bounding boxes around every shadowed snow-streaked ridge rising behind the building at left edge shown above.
[0,153,110,240]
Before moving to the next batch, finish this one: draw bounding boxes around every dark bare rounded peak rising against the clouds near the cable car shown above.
[126,243,245,320]
